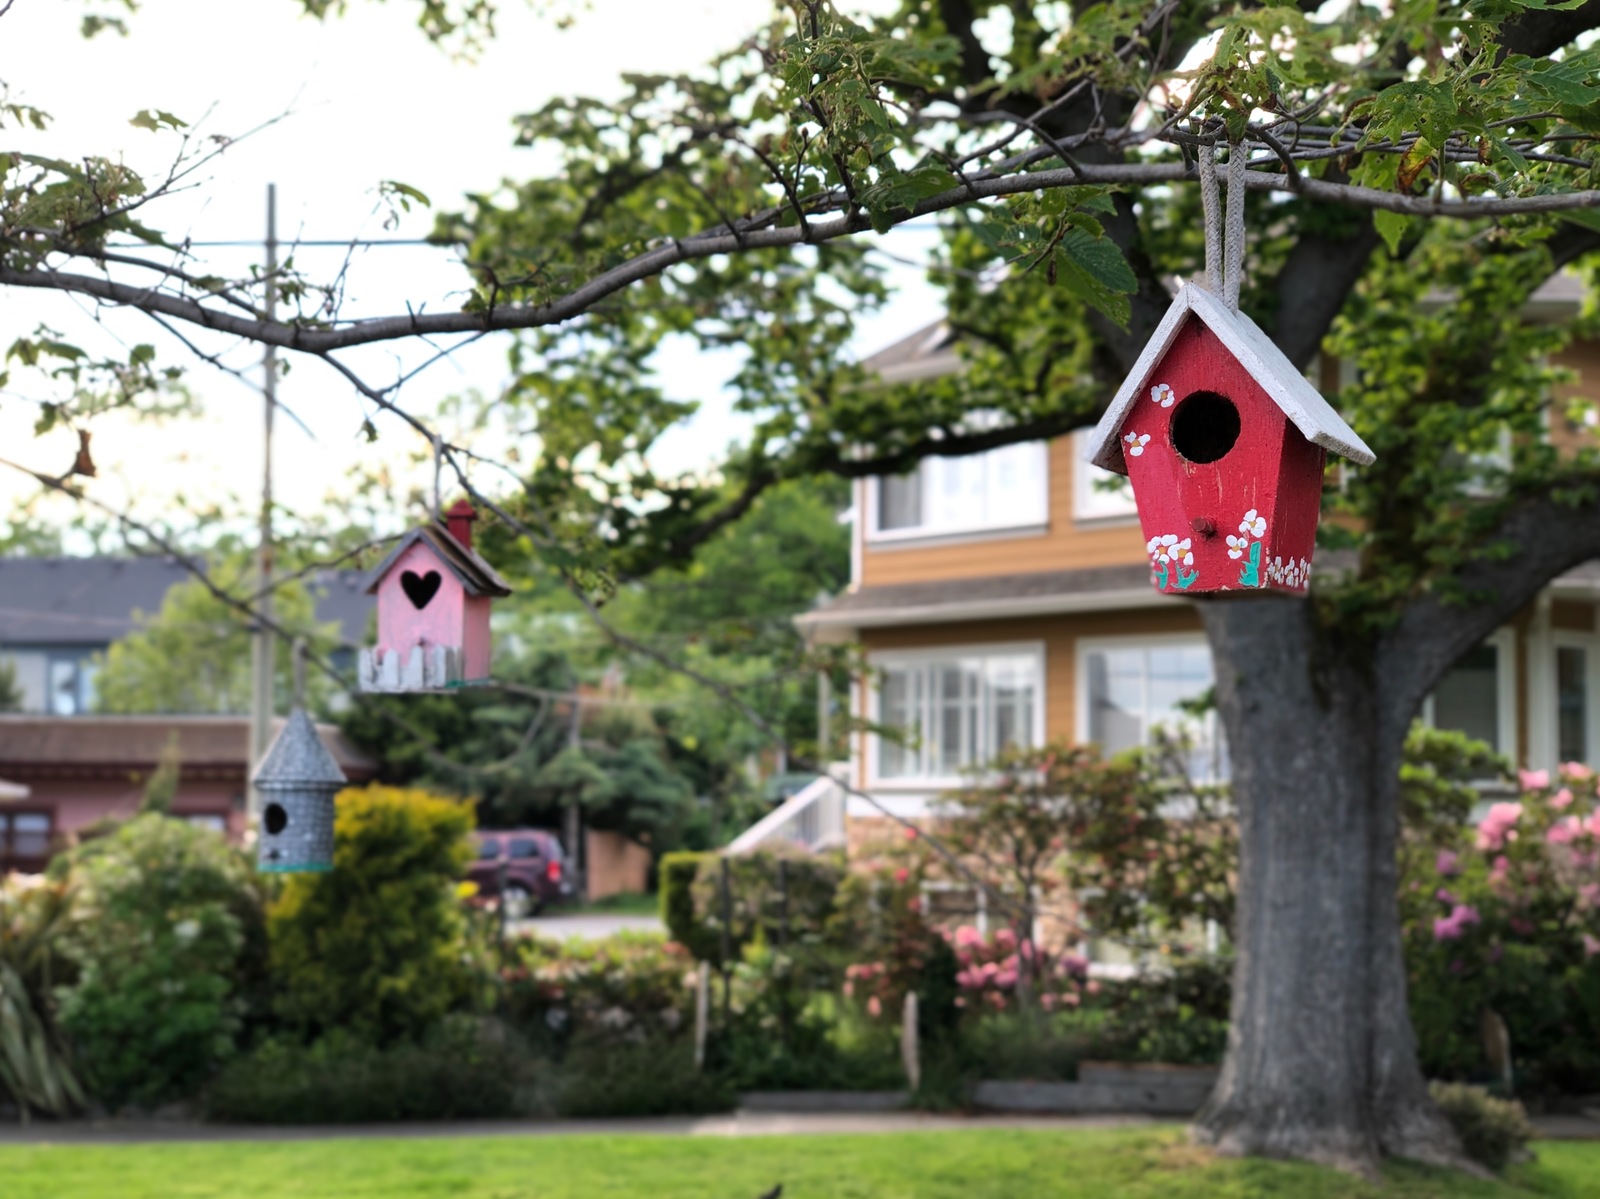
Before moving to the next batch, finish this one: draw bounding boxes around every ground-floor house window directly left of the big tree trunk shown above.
[1078,637,1227,783]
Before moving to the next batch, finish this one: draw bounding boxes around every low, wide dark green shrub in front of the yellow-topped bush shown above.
[205,1018,533,1124]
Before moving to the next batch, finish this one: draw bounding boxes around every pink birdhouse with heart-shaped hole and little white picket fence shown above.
[360,499,510,692]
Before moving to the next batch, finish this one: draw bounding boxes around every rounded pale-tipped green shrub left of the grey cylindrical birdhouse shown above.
[59,813,261,1108]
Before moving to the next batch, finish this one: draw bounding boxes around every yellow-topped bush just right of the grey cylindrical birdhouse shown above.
[267,786,474,1045]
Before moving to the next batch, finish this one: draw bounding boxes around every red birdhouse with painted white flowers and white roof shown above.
[1086,283,1373,594]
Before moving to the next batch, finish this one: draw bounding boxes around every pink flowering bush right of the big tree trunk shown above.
[1400,762,1600,1089]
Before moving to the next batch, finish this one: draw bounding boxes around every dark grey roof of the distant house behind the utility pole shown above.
[0,557,373,647]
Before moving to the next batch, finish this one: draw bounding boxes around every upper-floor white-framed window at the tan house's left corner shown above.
[867,442,1050,539]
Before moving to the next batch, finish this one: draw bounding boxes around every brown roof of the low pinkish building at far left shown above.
[0,712,378,781]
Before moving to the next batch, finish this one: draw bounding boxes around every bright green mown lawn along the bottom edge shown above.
[0,1129,1600,1199]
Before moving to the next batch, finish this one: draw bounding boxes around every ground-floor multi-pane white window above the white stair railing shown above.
[874,648,1045,781]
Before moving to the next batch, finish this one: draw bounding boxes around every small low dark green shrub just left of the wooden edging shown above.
[555,1039,736,1117]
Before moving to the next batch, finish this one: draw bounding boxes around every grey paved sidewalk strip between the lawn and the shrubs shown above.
[0,1111,1600,1146]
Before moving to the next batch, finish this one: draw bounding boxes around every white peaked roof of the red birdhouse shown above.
[1085,283,1376,474]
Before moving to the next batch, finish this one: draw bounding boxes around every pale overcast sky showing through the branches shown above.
[0,0,939,541]
